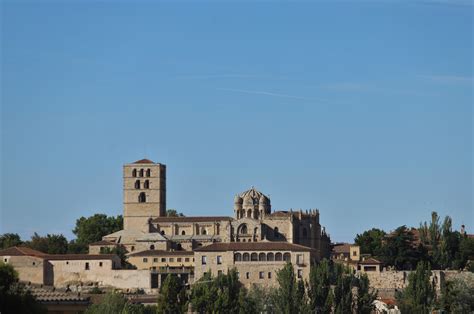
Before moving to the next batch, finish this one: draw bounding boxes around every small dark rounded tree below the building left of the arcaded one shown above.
[157,274,186,314]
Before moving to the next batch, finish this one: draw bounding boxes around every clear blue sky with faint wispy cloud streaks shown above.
[0,0,474,242]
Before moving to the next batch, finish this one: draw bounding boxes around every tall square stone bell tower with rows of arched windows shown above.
[123,159,166,230]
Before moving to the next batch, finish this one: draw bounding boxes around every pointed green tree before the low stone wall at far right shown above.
[397,261,435,314]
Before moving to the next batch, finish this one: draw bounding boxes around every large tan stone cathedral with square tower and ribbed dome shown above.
[89,159,330,286]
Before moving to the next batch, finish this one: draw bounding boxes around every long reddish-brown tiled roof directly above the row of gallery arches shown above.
[195,242,312,252]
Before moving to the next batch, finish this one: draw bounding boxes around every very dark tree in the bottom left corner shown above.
[0,262,46,314]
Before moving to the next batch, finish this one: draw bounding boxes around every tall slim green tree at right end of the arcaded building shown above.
[308,259,331,313]
